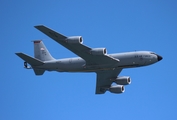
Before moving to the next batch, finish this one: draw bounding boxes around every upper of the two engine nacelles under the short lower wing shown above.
[113,76,131,85]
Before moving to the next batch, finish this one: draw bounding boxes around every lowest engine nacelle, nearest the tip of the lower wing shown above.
[109,85,125,94]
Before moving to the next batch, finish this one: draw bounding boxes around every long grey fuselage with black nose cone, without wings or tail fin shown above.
[35,51,162,72]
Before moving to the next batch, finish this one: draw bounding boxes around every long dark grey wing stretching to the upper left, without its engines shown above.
[35,25,119,66]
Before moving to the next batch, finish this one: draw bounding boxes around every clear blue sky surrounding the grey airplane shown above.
[0,0,177,120]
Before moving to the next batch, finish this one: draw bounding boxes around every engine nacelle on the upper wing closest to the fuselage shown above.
[90,48,107,55]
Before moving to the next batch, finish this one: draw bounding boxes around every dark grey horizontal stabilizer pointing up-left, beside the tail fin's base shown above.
[15,53,44,66]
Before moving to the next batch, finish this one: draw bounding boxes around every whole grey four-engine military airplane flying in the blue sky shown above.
[15,25,163,94]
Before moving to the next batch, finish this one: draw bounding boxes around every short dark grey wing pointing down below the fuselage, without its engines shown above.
[95,68,122,94]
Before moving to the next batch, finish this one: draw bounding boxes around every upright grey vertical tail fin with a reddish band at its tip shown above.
[34,40,54,61]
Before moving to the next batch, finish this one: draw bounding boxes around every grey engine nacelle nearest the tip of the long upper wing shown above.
[66,36,83,44]
